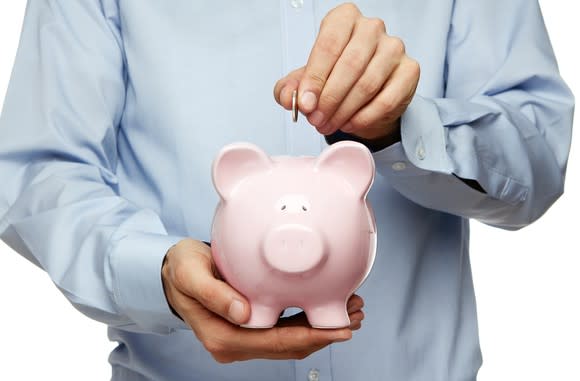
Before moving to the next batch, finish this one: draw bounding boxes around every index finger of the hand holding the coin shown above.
[298,4,360,114]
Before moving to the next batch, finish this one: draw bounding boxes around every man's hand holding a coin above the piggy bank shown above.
[274,3,420,139]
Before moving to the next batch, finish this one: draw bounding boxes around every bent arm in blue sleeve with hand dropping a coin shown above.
[274,0,574,229]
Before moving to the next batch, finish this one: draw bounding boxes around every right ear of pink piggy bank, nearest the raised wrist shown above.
[314,141,375,197]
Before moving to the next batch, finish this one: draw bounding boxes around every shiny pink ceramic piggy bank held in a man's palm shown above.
[211,141,376,328]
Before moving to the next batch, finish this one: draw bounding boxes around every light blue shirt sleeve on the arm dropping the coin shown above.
[374,0,574,230]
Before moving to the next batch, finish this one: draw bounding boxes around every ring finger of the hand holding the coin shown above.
[321,37,405,135]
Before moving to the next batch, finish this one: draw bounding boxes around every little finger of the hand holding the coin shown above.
[341,58,419,133]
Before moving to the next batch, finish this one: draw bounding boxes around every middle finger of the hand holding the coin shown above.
[308,18,385,133]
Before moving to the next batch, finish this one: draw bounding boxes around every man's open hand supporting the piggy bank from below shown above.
[162,239,364,363]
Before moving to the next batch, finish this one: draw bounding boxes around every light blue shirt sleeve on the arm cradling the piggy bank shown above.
[0,0,186,334]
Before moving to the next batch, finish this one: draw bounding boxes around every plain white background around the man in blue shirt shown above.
[0,0,580,381]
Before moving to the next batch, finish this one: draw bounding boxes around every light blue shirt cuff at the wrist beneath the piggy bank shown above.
[111,233,189,334]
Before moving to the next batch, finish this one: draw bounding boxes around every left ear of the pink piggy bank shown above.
[212,143,272,200]
